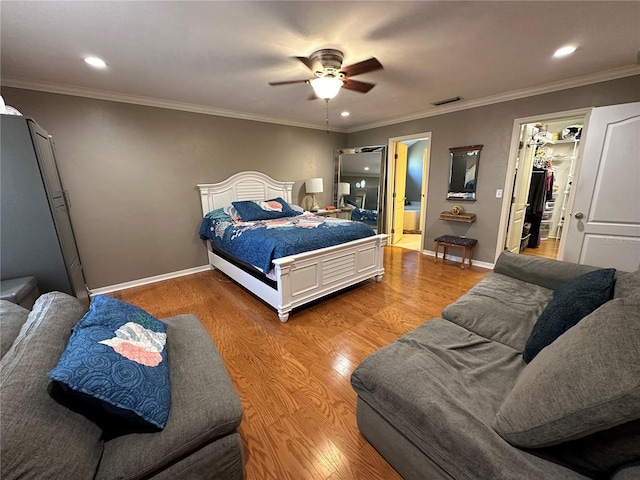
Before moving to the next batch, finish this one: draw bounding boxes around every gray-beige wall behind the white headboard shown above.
[2,87,347,288]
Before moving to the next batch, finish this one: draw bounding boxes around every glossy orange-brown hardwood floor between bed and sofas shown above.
[112,246,489,480]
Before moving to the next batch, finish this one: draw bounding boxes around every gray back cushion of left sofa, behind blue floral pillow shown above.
[0,292,103,480]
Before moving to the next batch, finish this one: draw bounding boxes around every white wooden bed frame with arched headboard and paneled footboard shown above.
[198,172,387,322]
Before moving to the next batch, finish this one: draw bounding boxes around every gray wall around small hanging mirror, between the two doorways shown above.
[349,76,640,263]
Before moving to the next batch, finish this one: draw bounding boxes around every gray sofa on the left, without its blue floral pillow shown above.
[0,292,244,480]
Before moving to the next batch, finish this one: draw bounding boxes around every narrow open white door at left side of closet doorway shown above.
[506,125,535,253]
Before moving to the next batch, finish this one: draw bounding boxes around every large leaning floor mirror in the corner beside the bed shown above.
[333,145,386,233]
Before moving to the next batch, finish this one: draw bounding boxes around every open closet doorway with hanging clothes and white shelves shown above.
[496,110,588,259]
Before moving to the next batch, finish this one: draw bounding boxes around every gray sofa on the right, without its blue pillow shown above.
[351,252,640,480]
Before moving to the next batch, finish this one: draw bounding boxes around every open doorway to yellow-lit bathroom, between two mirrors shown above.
[385,132,431,251]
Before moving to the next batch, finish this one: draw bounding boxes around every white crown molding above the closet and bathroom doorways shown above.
[347,65,640,133]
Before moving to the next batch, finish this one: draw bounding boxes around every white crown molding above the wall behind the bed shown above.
[0,78,347,133]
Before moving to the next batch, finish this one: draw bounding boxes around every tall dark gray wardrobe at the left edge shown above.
[0,115,88,303]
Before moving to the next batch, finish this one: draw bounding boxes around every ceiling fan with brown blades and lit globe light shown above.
[269,48,383,101]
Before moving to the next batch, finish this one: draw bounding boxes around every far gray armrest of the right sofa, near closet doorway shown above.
[493,251,599,290]
